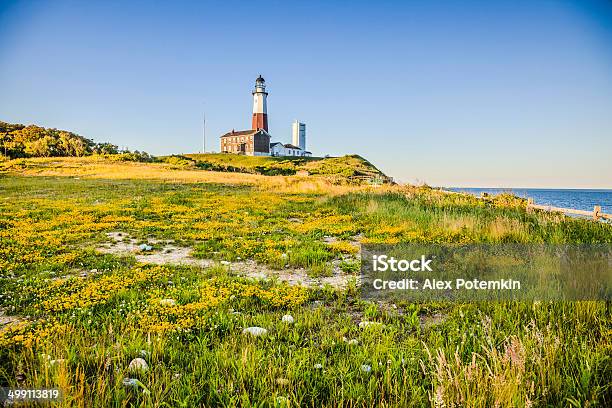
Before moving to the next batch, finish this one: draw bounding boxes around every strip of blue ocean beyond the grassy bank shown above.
[447,187,612,214]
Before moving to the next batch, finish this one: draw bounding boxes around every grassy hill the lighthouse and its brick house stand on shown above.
[160,153,390,182]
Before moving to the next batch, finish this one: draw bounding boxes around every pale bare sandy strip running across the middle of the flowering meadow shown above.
[96,231,358,288]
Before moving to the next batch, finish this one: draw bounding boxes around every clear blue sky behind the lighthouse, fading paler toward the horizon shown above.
[0,0,612,188]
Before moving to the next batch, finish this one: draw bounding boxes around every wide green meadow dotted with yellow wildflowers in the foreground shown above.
[0,157,612,407]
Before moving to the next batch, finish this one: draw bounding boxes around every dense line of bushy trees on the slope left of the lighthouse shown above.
[0,121,150,159]
